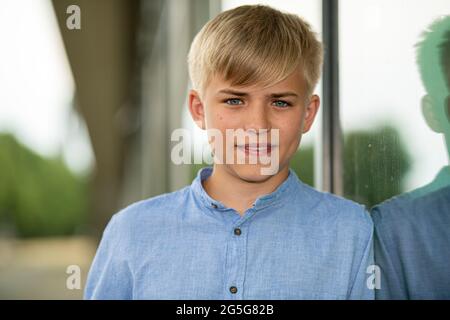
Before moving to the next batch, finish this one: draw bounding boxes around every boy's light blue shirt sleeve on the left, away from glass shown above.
[84,214,133,300]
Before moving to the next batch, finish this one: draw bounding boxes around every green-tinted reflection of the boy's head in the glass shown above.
[417,16,450,139]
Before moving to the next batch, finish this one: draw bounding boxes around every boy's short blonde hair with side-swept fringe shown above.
[188,5,323,99]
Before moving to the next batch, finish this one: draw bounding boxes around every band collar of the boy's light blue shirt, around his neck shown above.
[191,166,299,211]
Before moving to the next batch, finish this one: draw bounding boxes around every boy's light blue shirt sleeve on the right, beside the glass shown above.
[348,213,375,300]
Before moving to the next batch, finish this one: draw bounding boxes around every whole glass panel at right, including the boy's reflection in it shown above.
[339,0,450,299]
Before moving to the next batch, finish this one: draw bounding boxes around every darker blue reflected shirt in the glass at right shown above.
[372,167,450,300]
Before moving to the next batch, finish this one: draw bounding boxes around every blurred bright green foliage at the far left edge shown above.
[0,134,89,237]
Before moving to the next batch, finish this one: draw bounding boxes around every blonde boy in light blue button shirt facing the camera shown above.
[85,5,374,299]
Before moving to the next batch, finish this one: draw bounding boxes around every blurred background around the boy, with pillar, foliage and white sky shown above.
[0,0,449,299]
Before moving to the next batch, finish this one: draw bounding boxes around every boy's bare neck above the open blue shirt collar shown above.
[202,164,289,216]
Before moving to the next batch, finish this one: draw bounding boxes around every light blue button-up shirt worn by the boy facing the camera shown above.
[85,167,374,300]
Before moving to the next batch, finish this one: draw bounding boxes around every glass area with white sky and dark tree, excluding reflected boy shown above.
[339,0,449,206]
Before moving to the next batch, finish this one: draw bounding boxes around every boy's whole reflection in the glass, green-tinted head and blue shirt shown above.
[372,16,450,299]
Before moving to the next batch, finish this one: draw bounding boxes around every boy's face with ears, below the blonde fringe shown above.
[189,68,320,182]
